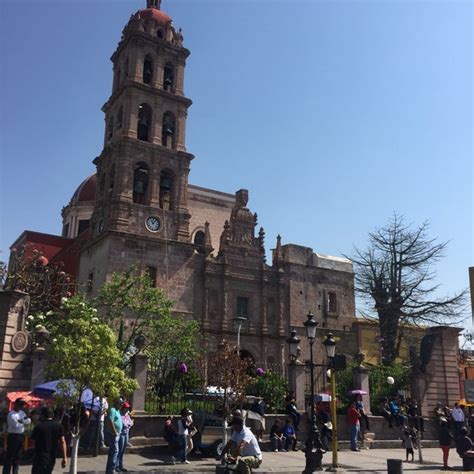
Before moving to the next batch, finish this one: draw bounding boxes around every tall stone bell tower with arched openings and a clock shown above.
[91,0,193,242]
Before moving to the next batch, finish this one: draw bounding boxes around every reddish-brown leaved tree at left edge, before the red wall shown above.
[0,245,74,313]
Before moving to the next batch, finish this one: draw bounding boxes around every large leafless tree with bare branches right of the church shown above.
[352,215,466,365]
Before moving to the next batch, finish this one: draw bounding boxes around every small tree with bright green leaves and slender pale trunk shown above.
[45,296,138,474]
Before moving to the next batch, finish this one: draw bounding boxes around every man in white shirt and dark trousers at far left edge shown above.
[3,398,31,474]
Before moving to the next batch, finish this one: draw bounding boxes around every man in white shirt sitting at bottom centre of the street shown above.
[222,416,263,474]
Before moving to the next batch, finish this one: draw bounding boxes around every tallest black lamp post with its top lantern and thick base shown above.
[303,312,323,474]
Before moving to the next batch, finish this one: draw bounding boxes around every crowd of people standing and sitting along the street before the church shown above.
[3,393,474,474]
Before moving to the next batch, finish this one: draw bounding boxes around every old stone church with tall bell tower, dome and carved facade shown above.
[12,0,358,365]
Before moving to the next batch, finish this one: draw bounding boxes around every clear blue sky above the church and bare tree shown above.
[0,0,474,332]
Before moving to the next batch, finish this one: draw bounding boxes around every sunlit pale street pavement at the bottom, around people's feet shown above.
[20,448,463,474]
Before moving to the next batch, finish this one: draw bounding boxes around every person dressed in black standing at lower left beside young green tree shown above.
[31,407,67,474]
